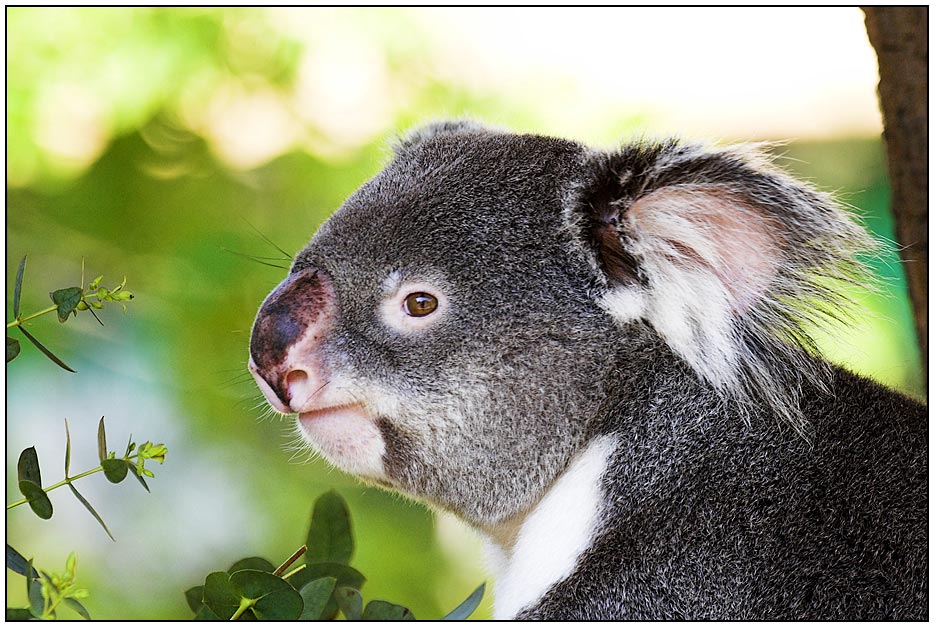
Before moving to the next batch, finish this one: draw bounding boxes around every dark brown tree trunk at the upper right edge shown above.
[863,6,928,376]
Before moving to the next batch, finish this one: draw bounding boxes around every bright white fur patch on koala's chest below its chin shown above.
[488,438,616,619]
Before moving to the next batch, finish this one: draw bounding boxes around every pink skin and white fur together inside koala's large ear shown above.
[622,185,781,388]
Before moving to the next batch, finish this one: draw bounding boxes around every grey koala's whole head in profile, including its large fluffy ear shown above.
[249,122,864,527]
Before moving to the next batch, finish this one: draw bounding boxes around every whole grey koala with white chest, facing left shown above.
[249,121,928,620]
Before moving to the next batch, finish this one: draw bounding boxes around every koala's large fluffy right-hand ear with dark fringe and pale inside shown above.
[581,141,873,429]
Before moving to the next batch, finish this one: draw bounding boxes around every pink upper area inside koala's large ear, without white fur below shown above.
[626,186,782,313]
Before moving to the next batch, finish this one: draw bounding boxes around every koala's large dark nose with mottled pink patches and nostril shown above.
[249,268,337,413]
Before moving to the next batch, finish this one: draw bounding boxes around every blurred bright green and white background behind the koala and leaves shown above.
[6,8,924,619]
